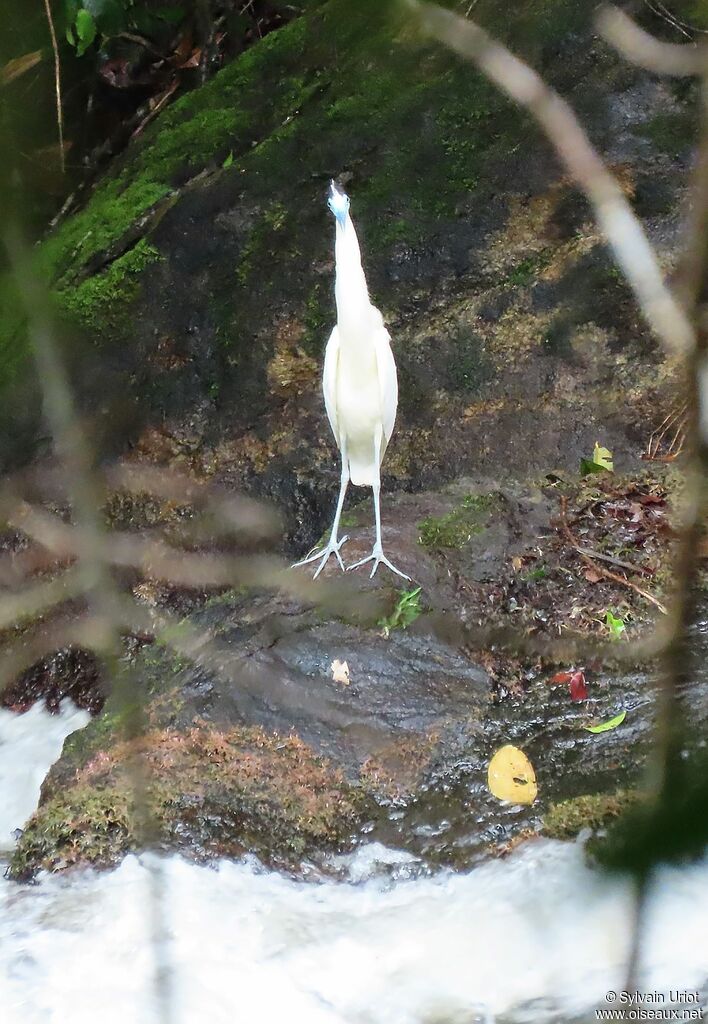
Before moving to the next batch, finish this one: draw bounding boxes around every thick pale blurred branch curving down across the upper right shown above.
[405,0,695,355]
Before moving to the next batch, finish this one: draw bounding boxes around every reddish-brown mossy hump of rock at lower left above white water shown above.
[10,725,368,879]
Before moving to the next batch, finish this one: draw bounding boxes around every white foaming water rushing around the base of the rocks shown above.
[0,702,708,1024]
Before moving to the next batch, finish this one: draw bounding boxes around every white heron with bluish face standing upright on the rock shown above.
[296,181,410,580]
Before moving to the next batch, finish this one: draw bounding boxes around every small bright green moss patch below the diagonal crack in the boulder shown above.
[58,239,160,331]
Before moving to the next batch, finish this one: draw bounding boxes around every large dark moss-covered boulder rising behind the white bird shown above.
[0,0,694,547]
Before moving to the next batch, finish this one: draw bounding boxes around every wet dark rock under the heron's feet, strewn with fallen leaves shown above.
[13,475,708,874]
